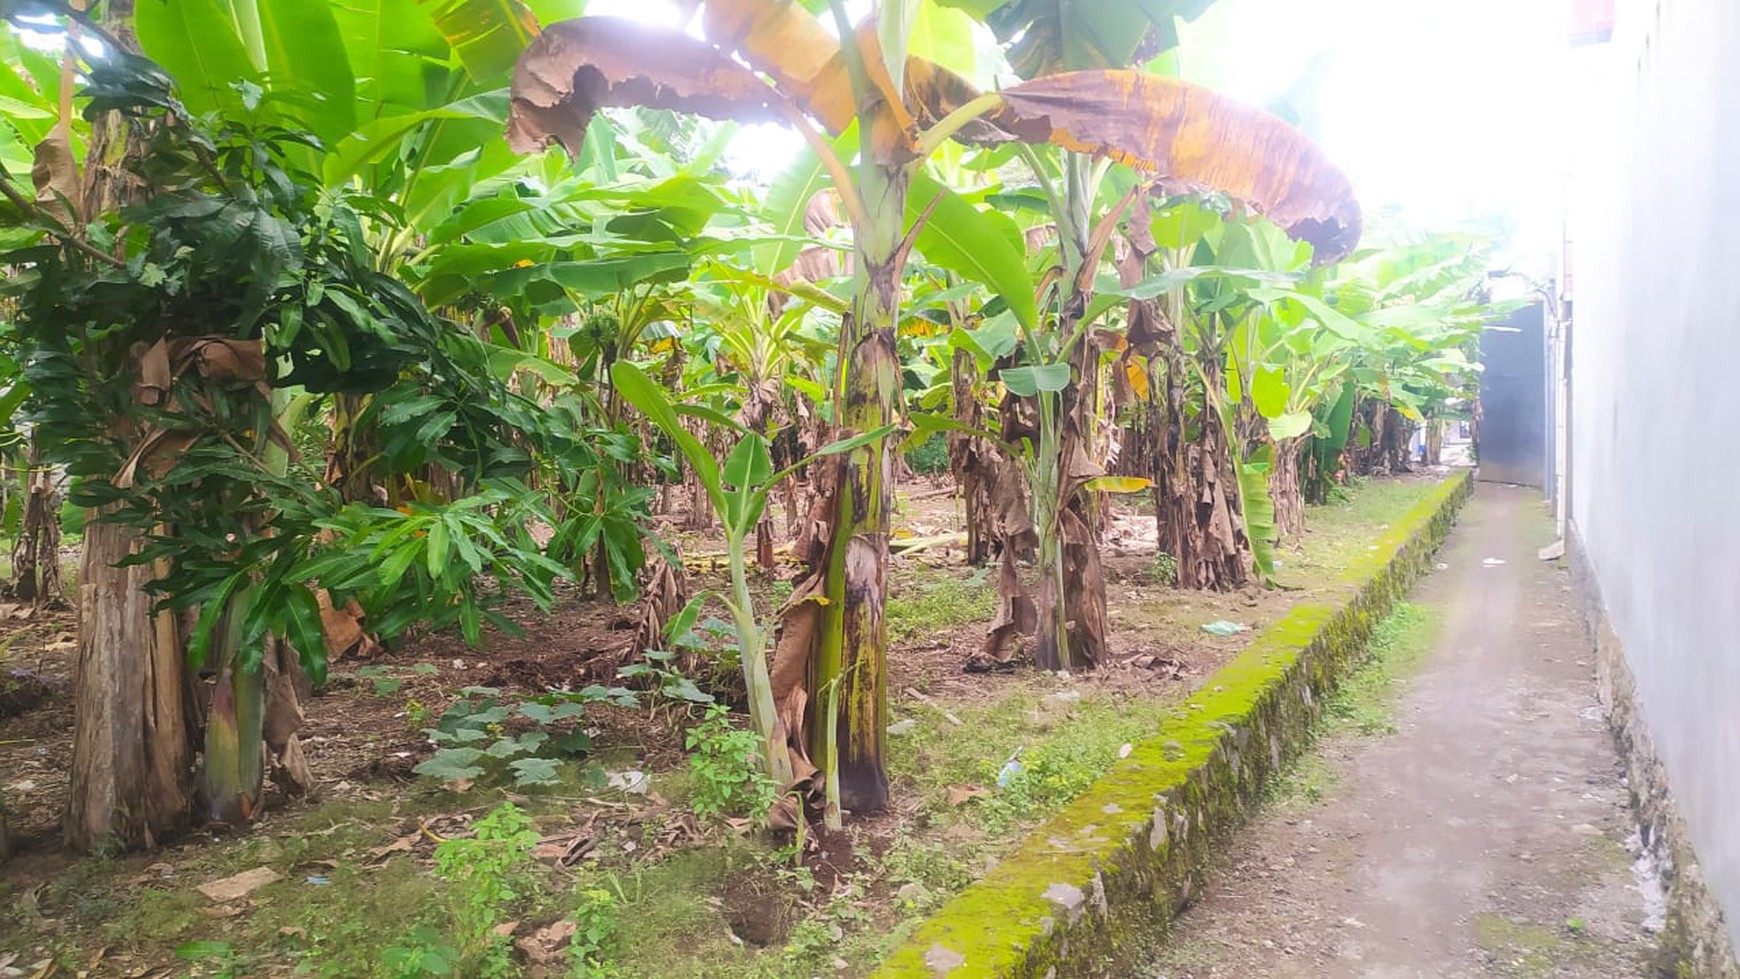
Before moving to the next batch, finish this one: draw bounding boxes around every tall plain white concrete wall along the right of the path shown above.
[1568,0,1740,942]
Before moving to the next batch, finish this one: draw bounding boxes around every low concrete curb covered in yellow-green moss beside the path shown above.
[872,473,1474,979]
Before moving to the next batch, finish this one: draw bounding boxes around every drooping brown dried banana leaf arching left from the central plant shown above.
[508,17,785,153]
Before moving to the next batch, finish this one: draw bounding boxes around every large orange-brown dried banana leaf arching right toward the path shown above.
[990,71,1361,263]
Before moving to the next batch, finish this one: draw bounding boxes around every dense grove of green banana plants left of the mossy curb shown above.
[0,0,1502,849]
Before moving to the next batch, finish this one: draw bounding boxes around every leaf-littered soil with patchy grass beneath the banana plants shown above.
[0,478,1436,979]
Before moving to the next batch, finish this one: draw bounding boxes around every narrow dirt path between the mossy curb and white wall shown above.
[1138,483,1653,979]
